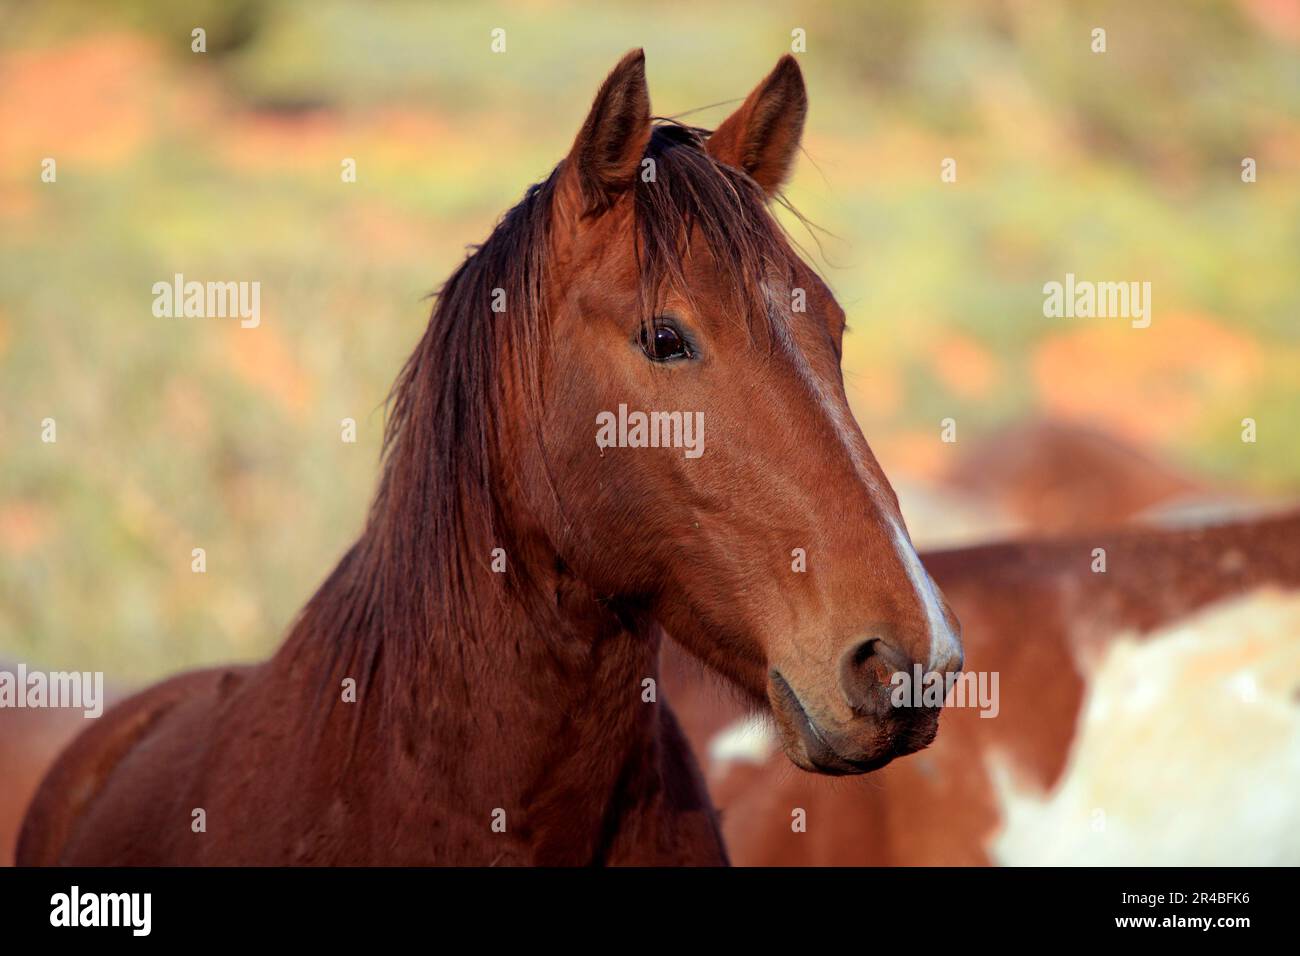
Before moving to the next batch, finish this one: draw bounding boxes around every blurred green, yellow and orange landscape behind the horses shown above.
[0,0,1300,687]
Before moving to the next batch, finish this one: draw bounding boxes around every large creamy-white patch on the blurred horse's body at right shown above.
[989,589,1300,866]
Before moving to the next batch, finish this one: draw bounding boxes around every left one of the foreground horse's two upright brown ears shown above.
[562,49,650,215]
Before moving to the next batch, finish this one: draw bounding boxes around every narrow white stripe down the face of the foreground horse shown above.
[763,282,962,670]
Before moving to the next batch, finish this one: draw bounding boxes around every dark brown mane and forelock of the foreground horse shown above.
[286,121,793,733]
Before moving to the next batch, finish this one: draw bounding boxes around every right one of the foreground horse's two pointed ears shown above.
[709,53,809,195]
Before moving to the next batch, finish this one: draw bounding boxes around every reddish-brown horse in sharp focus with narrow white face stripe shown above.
[18,51,962,865]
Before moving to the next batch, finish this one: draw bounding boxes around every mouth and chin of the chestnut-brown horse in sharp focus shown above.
[768,670,937,777]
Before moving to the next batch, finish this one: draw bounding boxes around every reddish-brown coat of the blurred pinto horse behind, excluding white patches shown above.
[663,510,1300,866]
